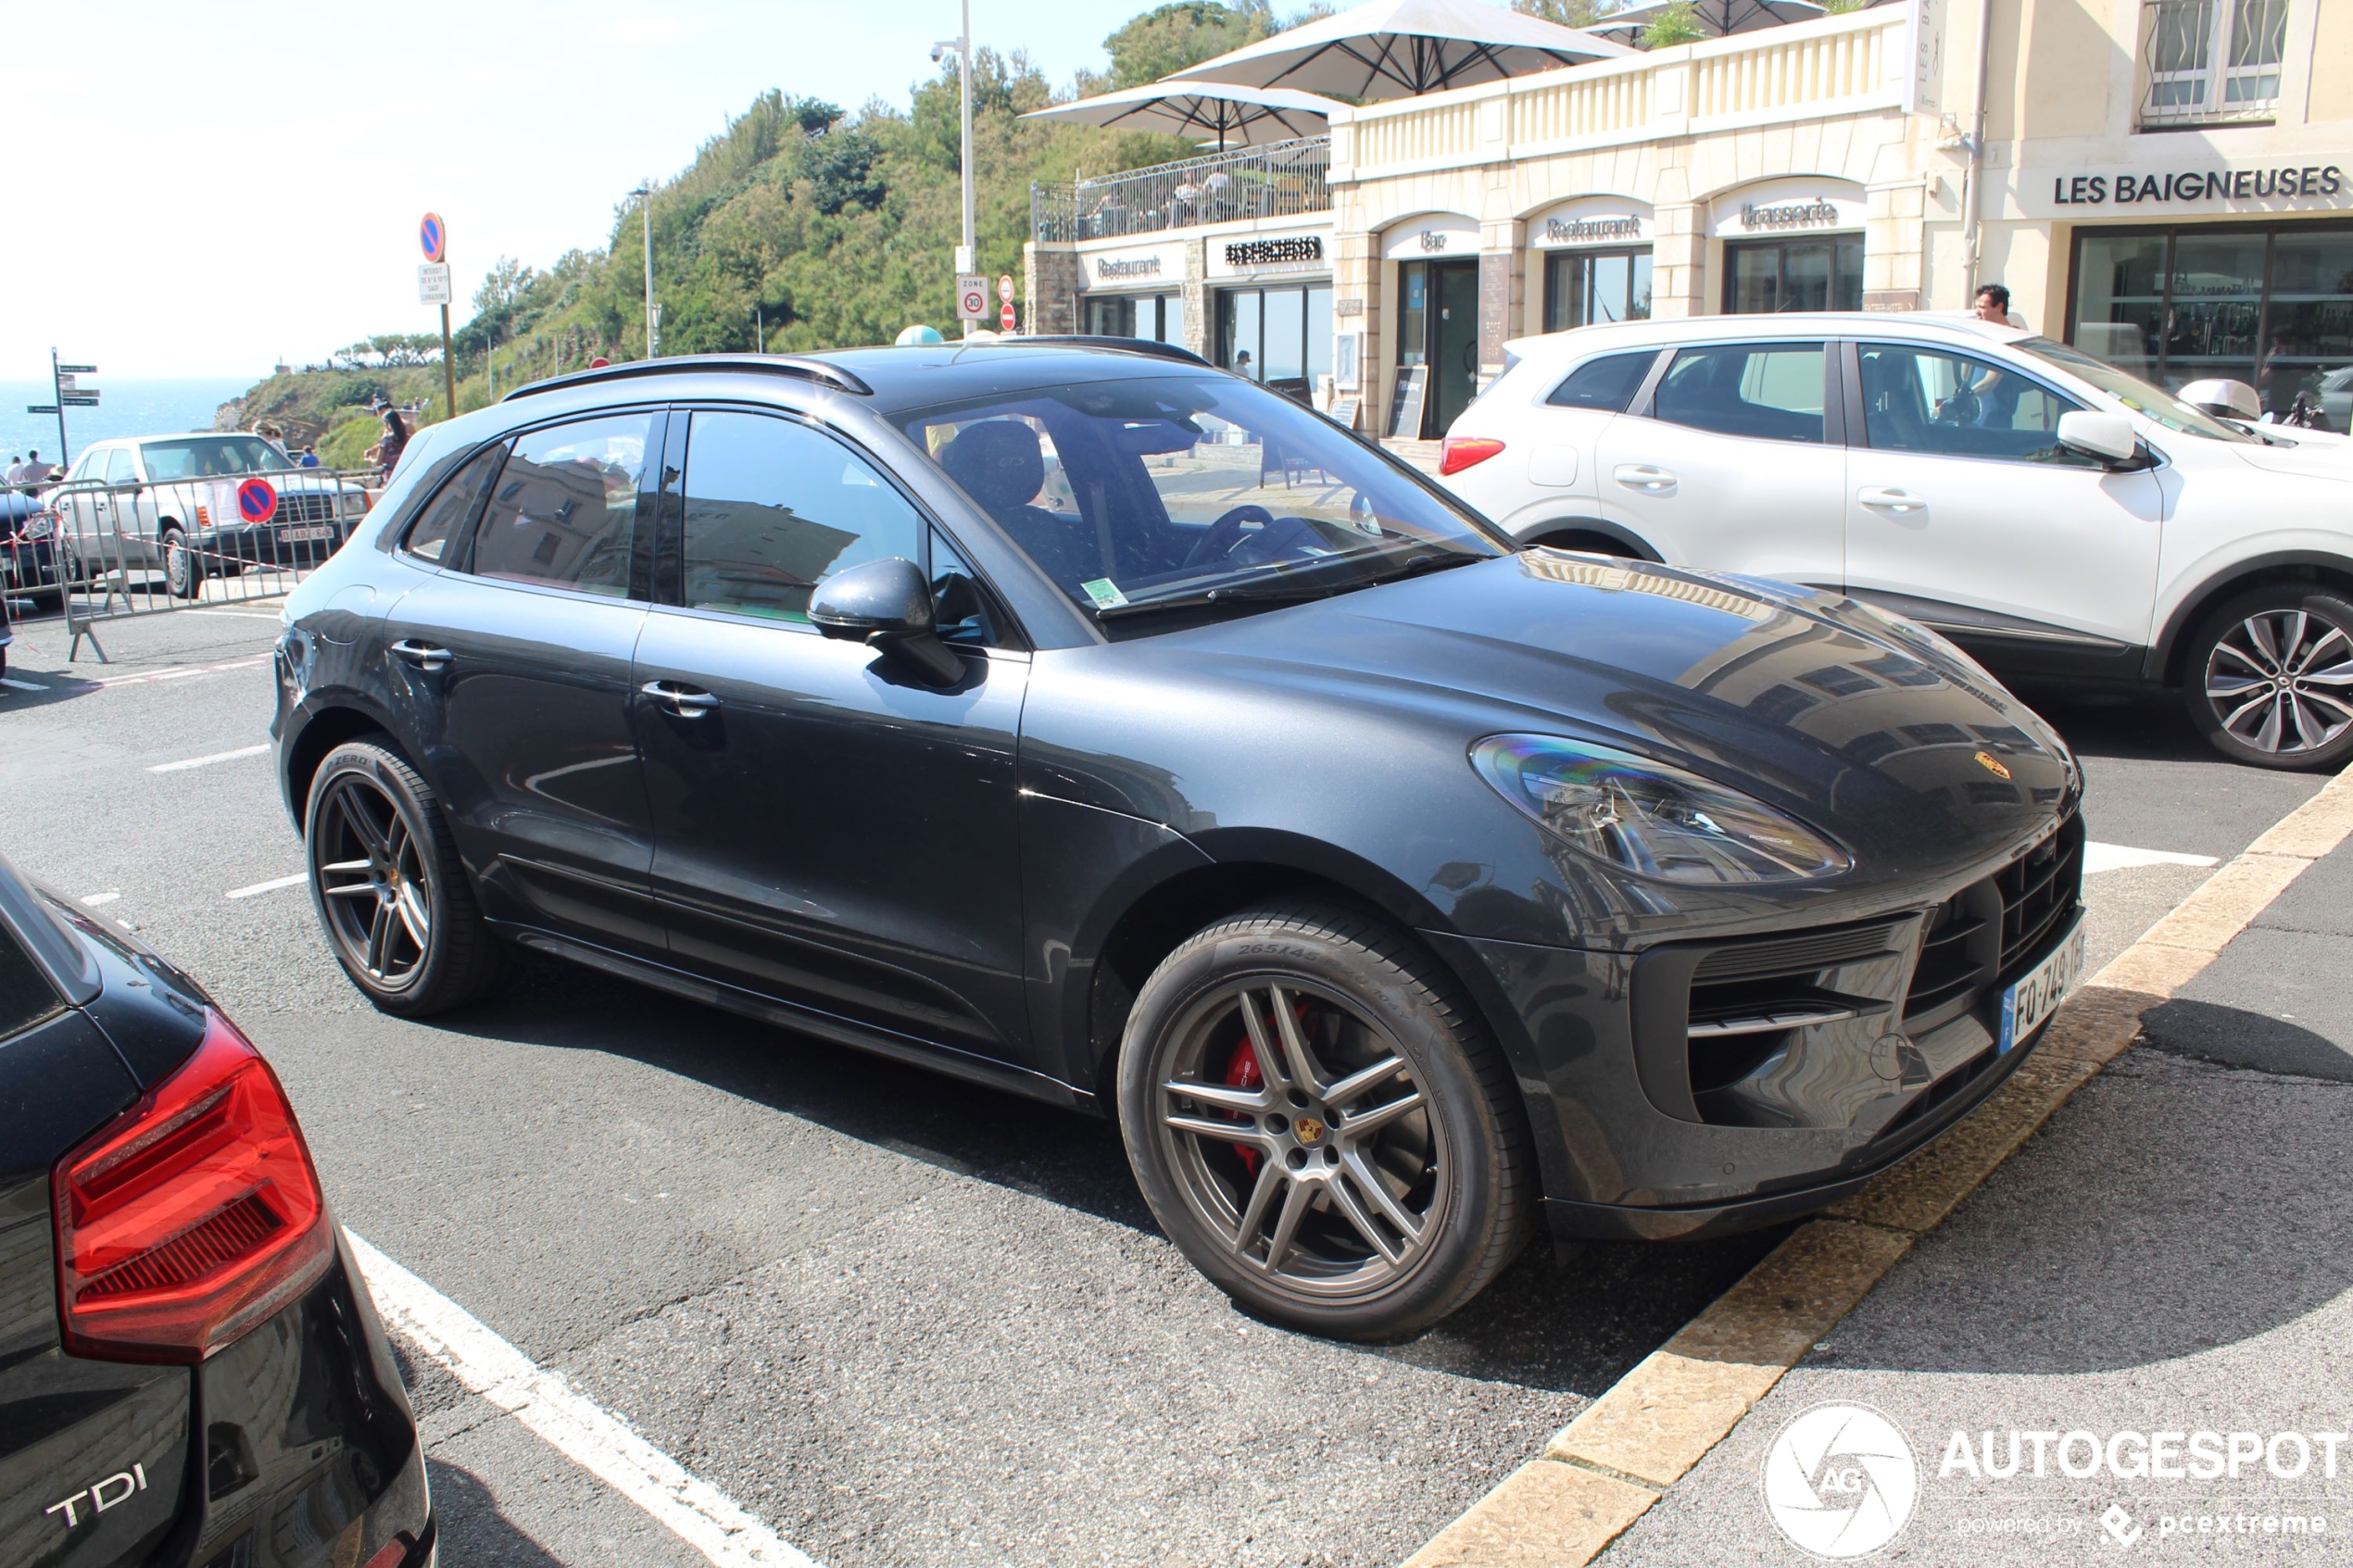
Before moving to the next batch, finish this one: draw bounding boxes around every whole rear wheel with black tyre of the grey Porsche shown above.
[304,741,506,1018]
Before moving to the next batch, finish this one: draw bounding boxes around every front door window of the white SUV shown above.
[1859,344,2096,468]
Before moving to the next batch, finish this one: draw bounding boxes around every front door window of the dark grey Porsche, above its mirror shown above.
[683,411,925,623]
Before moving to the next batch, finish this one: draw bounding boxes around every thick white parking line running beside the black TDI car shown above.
[344,1229,819,1568]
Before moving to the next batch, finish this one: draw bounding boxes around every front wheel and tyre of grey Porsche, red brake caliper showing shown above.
[1120,905,1534,1340]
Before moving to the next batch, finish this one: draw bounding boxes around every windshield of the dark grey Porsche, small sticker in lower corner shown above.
[899,376,1504,616]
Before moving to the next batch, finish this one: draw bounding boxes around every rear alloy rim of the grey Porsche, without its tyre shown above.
[310,773,433,990]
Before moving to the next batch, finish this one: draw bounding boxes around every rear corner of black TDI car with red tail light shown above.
[0,860,433,1568]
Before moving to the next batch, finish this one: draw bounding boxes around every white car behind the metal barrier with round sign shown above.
[44,430,370,599]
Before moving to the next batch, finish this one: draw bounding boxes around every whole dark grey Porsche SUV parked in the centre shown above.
[273,339,2082,1337]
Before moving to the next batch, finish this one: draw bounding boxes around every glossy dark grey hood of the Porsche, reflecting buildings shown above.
[1176,550,2080,872]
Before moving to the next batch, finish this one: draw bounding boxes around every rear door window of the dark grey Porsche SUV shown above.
[473,414,654,599]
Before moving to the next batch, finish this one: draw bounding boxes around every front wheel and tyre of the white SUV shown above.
[2183,583,2353,769]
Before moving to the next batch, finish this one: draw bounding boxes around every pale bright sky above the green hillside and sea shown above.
[0,0,1252,388]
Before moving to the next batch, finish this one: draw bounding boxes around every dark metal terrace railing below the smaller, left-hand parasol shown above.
[1031,136,1332,245]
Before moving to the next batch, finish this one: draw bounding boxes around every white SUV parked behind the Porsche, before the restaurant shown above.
[1440,315,2353,766]
